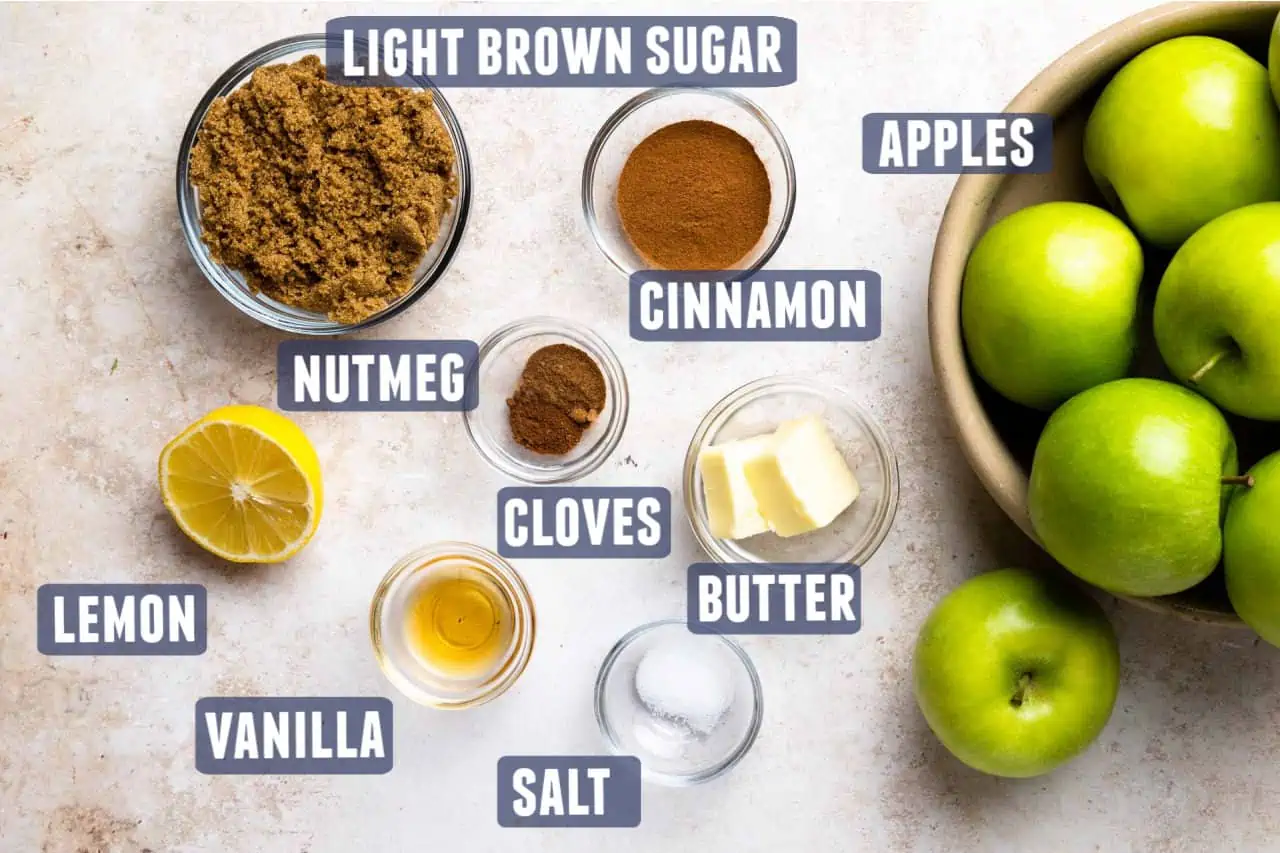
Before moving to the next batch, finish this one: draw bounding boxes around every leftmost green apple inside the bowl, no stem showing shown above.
[960,201,1142,410]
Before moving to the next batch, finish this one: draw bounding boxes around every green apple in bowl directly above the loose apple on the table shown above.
[1027,379,1236,596]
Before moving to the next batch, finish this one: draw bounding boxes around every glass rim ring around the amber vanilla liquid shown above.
[369,540,538,711]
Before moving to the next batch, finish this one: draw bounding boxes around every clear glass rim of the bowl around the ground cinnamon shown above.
[582,86,796,275]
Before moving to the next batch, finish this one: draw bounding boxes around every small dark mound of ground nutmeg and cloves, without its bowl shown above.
[507,343,607,456]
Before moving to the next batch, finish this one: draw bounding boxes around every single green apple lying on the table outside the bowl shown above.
[915,569,1120,777]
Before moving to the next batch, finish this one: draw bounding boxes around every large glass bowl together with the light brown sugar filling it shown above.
[178,35,471,334]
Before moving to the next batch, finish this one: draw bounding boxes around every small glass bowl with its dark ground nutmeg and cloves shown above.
[463,316,628,484]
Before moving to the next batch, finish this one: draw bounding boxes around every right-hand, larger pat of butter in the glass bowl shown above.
[744,415,859,537]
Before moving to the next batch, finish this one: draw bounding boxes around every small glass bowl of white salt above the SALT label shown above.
[595,619,764,786]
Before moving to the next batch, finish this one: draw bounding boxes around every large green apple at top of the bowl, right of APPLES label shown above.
[1084,36,1280,248]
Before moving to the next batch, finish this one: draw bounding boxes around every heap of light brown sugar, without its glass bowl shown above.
[191,56,457,323]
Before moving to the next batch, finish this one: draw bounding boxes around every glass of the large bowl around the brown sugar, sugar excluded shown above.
[178,33,471,334]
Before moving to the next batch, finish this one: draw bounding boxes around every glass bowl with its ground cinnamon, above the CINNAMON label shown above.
[582,87,795,275]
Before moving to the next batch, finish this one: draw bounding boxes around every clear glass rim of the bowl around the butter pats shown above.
[684,374,899,566]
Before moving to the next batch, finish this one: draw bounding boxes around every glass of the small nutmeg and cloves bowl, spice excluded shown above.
[462,316,628,484]
